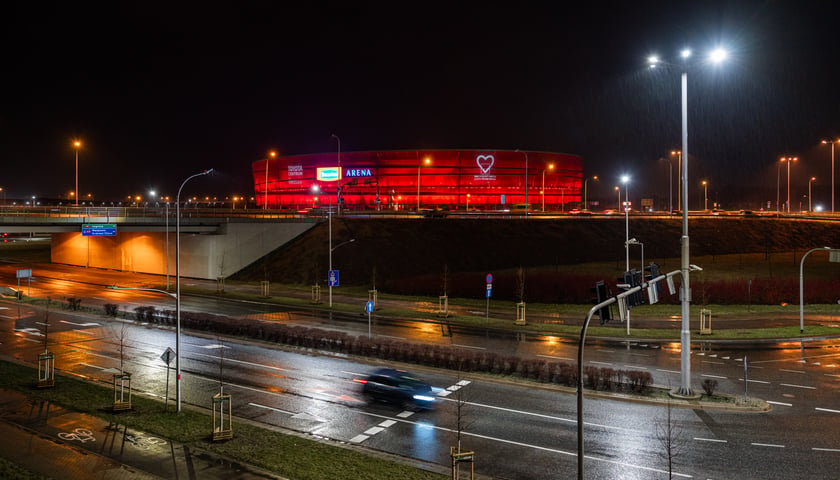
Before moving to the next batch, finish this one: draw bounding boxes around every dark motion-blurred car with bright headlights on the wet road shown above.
[353,368,437,408]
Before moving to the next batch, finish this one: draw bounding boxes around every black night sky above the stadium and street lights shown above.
[6,1,840,209]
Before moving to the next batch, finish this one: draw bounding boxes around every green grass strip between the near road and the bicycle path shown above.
[0,361,446,480]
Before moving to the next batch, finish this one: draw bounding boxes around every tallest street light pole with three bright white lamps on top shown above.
[648,48,727,397]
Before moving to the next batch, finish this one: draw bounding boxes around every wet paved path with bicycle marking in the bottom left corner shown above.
[0,390,282,480]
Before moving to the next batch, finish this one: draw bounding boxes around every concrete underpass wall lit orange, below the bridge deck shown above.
[51,220,318,279]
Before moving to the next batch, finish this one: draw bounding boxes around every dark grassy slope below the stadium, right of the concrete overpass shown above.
[233,217,840,303]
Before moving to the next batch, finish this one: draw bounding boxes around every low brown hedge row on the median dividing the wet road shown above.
[116,307,653,393]
